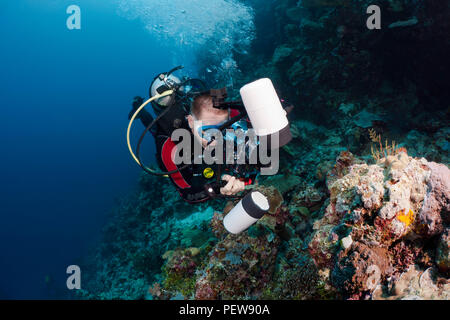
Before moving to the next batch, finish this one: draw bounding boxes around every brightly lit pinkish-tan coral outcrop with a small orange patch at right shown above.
[308,152,450,298]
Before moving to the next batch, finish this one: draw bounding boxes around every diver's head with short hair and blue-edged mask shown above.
[187,94,228,147]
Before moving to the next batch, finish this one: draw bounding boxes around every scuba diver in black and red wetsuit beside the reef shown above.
[127,66,291,203]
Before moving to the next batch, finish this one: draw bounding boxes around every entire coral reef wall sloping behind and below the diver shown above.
[81,0,450,299]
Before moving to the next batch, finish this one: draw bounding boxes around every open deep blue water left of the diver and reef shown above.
[0,0,181,299]
